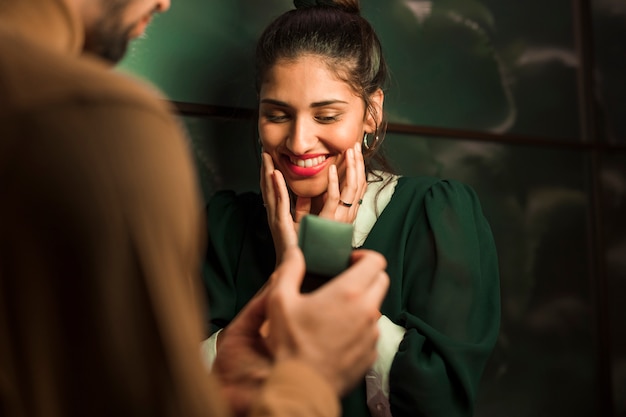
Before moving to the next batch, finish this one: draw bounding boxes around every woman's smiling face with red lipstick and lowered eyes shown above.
[259,55,382,197]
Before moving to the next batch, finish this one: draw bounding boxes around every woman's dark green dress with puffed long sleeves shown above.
[204,177,500,417]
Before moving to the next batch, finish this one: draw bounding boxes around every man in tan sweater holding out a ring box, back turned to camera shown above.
[0,0,388,417]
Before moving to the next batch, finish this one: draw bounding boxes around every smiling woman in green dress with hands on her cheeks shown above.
[205,0,500,417]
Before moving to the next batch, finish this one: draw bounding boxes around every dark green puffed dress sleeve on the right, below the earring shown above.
[389,181,500,417]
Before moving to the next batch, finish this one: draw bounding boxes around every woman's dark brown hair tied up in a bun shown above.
[256,0,391,178]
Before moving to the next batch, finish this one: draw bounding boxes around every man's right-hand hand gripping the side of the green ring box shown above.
[266,246,389,396]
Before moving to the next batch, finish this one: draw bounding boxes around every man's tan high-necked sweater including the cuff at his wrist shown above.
[0,0,339,417]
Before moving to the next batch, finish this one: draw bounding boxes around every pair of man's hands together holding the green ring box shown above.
[213,246,389,416]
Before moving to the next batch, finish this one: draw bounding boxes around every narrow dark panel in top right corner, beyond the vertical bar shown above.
[591,0,626,143]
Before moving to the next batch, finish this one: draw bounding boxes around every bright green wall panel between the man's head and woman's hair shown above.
[119,0,272,108]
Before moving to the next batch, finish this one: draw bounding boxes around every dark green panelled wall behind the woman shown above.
[120,0,626,417]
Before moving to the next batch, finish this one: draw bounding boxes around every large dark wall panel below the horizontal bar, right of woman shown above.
[386,134,596,417]
